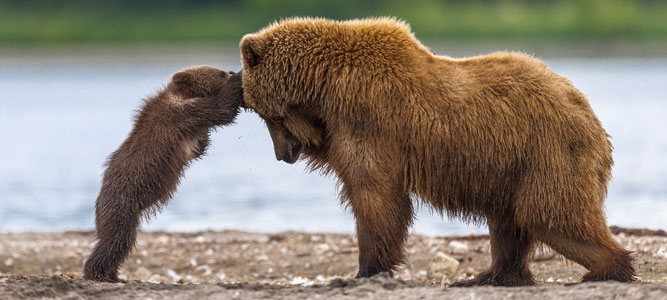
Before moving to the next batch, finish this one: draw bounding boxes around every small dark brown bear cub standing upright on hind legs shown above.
[84,66,242,282]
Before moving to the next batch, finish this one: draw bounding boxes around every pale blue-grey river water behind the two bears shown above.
[0,54,667,235]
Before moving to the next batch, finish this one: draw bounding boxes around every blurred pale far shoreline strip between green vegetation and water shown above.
[0,38,667,66]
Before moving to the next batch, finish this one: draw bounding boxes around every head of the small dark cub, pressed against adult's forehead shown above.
[167,66,240,99]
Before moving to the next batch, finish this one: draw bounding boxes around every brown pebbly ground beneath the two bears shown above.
[0,228,667,299]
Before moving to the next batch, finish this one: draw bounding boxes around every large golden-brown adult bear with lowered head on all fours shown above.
[241,18,635,286]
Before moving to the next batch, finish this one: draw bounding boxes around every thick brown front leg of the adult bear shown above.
[342,171,414,278]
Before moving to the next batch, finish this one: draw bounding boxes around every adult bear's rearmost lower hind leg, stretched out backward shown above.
[540,224,636,282]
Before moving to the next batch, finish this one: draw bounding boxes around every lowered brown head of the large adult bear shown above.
[241,20,334,164]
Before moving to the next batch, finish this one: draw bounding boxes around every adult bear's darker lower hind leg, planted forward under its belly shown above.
[450,217,536,287]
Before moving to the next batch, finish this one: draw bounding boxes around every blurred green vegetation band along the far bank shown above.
[0,0,667,45]
